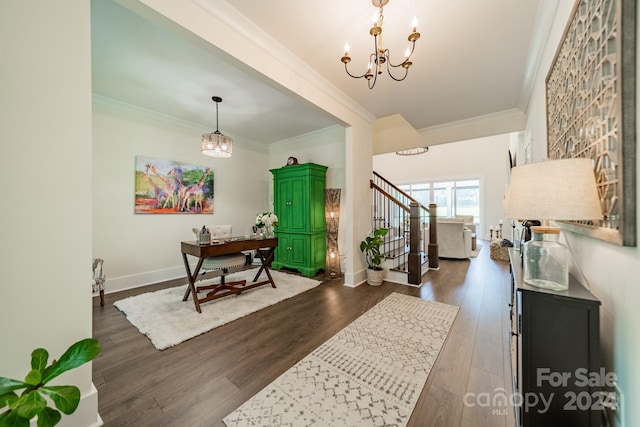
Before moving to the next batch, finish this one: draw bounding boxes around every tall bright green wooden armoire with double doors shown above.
[271,163,327,276]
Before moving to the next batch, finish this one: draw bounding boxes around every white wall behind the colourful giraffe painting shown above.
[93,97,271,292]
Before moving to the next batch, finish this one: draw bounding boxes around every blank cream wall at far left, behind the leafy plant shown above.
[0,0,98,426]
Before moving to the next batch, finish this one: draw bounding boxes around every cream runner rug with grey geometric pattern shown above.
[223,293,458,427]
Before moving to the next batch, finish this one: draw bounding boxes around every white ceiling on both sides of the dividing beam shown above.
[91,0,555,147]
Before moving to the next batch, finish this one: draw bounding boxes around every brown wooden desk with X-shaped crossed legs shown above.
[181,237,278,313]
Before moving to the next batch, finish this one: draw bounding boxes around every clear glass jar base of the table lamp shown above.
[523,227,569,291]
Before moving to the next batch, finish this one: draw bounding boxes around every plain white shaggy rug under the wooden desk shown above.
[113,269,322,350]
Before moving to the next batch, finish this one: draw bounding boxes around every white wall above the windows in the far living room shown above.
[373,134,511,240]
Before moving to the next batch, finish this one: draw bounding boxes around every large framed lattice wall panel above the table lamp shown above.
[546,0,637,246]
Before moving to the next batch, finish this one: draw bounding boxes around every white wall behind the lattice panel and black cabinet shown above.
[527,1,640,426]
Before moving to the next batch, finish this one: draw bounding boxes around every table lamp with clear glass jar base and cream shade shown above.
[504,158,602,291]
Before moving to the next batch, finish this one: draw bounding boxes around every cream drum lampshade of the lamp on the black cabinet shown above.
[504,158,603,220]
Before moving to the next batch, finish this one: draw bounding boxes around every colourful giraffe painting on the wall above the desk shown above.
[135,156,214,214]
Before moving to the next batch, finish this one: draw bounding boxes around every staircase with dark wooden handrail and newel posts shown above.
[370,172,438,286]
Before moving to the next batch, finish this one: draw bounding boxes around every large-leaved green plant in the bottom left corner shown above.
[0,338,100,427]
